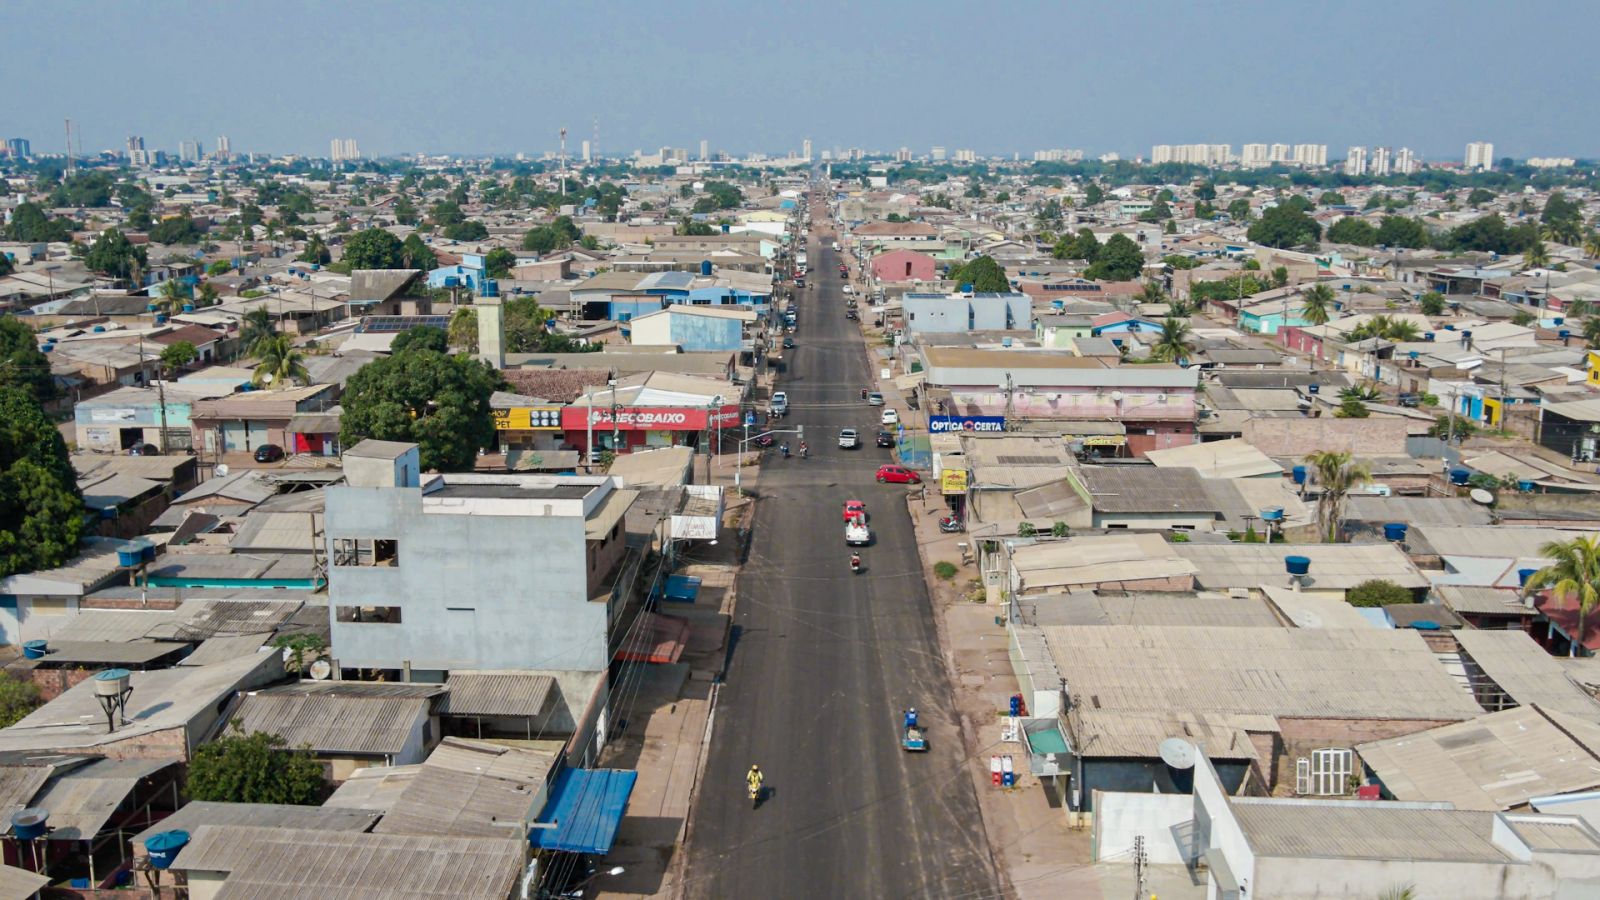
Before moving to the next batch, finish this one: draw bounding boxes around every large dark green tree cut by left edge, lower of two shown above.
[0,388,83,578]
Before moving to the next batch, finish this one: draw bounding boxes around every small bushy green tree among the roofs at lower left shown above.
[184,719,323,806]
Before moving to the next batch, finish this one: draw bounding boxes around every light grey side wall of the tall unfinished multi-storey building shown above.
[326,487,604,671]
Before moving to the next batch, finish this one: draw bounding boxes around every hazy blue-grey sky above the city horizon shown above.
[0,0,1600,159]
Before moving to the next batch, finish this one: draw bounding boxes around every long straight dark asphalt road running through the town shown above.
[683,192,1000,900]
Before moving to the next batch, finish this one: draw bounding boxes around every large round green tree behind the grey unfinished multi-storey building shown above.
[339,341,504,472]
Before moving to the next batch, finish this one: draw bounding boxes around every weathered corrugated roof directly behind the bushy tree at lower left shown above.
[234,689,430,754]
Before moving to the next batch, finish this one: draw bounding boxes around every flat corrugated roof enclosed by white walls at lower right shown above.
[1229,798,1512,863]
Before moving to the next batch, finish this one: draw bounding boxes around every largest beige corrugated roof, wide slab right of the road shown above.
[1043,625,1482,721]
